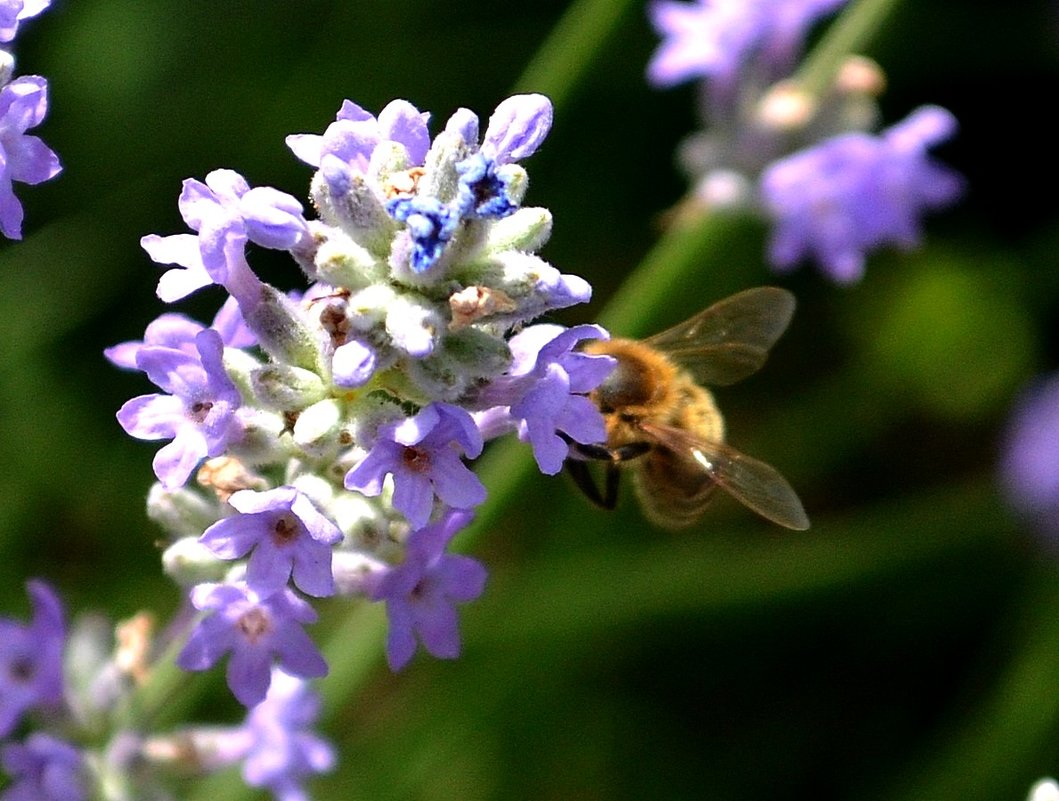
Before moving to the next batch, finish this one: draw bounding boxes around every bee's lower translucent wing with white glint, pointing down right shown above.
[643,423,809,531]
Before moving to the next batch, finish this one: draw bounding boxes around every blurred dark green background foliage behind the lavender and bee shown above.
[0,0,1059,801]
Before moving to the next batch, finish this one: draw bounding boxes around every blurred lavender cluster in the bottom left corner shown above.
[0,581,334,801]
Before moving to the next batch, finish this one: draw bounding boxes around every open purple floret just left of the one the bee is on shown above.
[345,403,485,529]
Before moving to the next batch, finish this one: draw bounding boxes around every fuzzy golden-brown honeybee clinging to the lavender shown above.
[567,286,809,530]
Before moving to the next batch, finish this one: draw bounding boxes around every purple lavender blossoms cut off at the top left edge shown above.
[0,0,61,239]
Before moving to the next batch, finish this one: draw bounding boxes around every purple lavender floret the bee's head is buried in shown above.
[482,324,615,476]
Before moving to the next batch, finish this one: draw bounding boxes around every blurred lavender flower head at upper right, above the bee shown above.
[647,0,963,284]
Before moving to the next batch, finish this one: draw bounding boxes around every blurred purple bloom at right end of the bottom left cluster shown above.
[243,669,335,801]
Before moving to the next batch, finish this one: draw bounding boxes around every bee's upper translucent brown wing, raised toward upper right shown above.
[644,286,794,387]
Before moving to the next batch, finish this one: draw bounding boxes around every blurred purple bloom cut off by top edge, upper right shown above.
[647,0,845,87]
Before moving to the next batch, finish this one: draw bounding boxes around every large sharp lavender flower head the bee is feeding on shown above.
[107,94,613,712]
